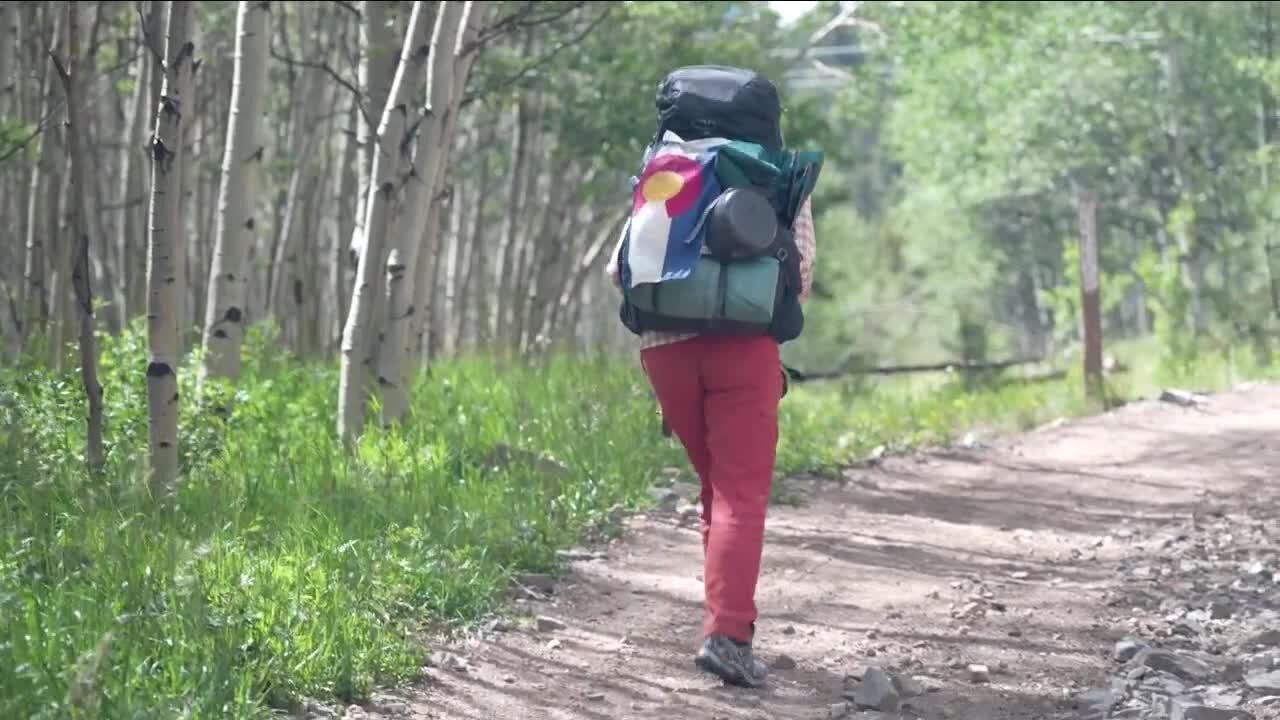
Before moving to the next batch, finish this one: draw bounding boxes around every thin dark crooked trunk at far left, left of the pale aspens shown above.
[54,3,105,471]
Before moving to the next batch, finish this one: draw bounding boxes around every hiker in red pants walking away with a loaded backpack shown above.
[608,65,822,687]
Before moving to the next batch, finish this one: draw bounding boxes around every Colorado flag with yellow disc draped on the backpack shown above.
[627,132,728,287]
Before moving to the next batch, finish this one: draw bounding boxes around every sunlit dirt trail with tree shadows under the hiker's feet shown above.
[373,386,1280,720]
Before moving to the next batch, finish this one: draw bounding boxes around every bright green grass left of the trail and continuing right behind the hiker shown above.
[0,325,1269,719]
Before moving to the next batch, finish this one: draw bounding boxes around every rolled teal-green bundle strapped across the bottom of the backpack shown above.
[632,255,782,327]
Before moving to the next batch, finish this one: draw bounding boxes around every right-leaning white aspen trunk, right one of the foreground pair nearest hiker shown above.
[378,3,471,423]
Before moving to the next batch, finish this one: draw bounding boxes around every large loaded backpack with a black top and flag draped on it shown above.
[618,65,822,342]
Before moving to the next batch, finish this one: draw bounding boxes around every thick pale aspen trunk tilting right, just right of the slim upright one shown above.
[200,0,271,386]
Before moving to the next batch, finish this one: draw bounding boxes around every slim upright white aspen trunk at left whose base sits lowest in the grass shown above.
[147,0,192,492]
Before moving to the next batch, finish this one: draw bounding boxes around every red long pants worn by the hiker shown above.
[641,337,782,642]
